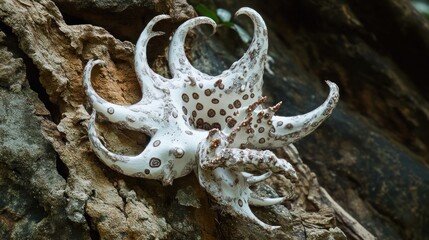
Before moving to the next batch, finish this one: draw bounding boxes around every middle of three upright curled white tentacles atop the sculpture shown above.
[168,17,216,77]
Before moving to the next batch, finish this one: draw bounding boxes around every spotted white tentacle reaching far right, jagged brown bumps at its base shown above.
[227,81,339,149]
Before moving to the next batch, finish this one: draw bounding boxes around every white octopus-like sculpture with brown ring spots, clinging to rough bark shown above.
[83,8,339,230]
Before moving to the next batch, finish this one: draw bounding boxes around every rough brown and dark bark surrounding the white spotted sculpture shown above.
[0,0,429,239]
